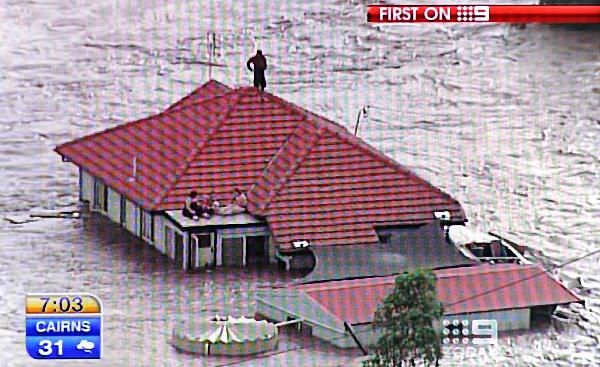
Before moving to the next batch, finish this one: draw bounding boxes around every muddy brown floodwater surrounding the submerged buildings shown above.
[0,0,600,366]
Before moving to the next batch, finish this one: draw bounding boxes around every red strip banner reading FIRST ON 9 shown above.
[367,5,600,24]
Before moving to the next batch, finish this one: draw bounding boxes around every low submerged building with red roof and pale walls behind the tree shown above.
[257,263,580,348]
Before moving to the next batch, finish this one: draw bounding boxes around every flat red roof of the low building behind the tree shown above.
[295,264,580,324]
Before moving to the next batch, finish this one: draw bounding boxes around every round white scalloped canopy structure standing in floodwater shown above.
[171,315,279,356]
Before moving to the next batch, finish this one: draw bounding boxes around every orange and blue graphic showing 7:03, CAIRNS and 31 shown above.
[25,293,102,359]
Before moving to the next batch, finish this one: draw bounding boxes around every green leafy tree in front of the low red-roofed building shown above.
[363,270,443,367]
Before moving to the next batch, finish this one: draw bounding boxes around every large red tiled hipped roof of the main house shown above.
[56,81,466,248]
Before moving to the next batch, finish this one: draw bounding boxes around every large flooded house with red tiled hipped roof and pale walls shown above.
[56,80,466,269]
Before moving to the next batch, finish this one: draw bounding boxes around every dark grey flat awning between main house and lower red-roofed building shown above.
[300,221,477,283]
